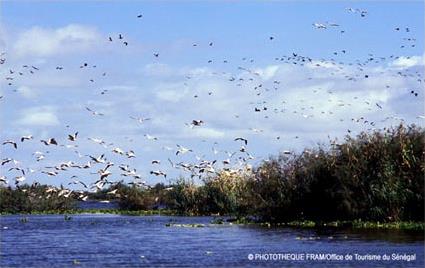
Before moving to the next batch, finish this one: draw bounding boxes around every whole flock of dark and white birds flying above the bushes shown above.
[0,8,424,201]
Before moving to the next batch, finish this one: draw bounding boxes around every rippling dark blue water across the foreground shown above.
[0,214,424,267]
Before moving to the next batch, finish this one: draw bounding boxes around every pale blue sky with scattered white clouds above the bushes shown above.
[0,1,424,188]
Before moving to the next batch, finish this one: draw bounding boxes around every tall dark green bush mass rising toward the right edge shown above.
[247,125,425,221]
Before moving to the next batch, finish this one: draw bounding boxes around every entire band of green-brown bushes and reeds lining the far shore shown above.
[0,125,425,231]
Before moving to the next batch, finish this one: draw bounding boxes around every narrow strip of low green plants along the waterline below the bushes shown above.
[0,209,425,231]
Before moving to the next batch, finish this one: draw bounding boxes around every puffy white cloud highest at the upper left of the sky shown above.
[13,24,101,57]
